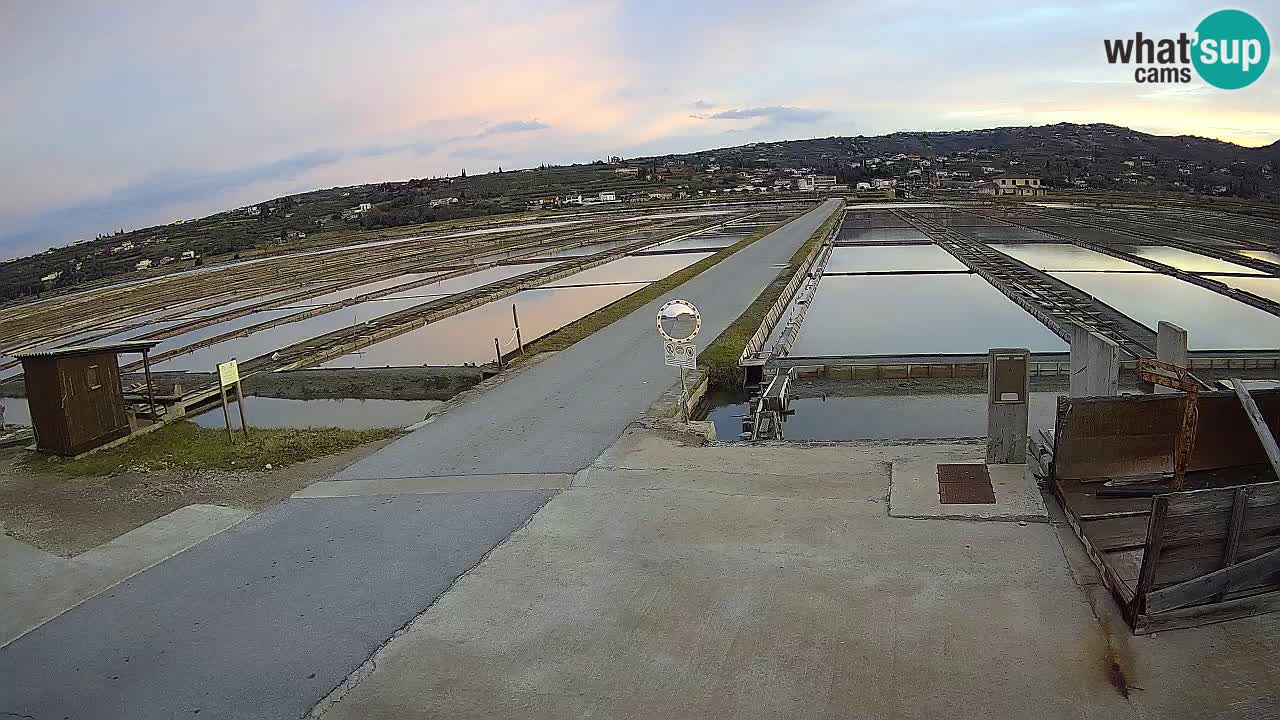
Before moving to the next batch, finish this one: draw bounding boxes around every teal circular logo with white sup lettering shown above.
[1192,10,1271,90]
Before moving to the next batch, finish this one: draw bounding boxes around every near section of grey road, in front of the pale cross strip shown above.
[0,491,554,720]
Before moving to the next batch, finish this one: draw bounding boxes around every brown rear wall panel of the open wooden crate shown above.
[1053,391,1280,482]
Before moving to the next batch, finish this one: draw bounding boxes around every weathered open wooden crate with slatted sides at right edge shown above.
[1046,391,1280,634]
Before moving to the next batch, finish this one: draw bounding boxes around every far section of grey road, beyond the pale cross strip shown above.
[335,200,840,480]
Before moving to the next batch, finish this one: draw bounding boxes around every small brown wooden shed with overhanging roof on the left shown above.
[15,341,159,455]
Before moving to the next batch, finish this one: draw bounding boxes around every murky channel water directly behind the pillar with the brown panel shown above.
[707,392,1059,441]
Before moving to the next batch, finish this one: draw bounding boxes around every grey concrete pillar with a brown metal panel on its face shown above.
[987,347,1032,464]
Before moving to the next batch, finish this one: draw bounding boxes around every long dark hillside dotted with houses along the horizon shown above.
[0,123,1280,302]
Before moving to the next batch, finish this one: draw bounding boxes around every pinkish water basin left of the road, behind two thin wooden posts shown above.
[323,283,645,368]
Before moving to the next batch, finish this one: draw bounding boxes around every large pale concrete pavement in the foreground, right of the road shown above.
[314,428,1280,720]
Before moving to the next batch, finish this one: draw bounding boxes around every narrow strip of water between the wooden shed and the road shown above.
[192,395,443,430]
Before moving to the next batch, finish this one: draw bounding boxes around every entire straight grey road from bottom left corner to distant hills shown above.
[0,201,838,720]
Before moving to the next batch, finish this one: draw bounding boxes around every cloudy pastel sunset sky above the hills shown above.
[0,0,1280,258]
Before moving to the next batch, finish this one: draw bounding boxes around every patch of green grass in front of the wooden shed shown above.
[26,420,399,477]
